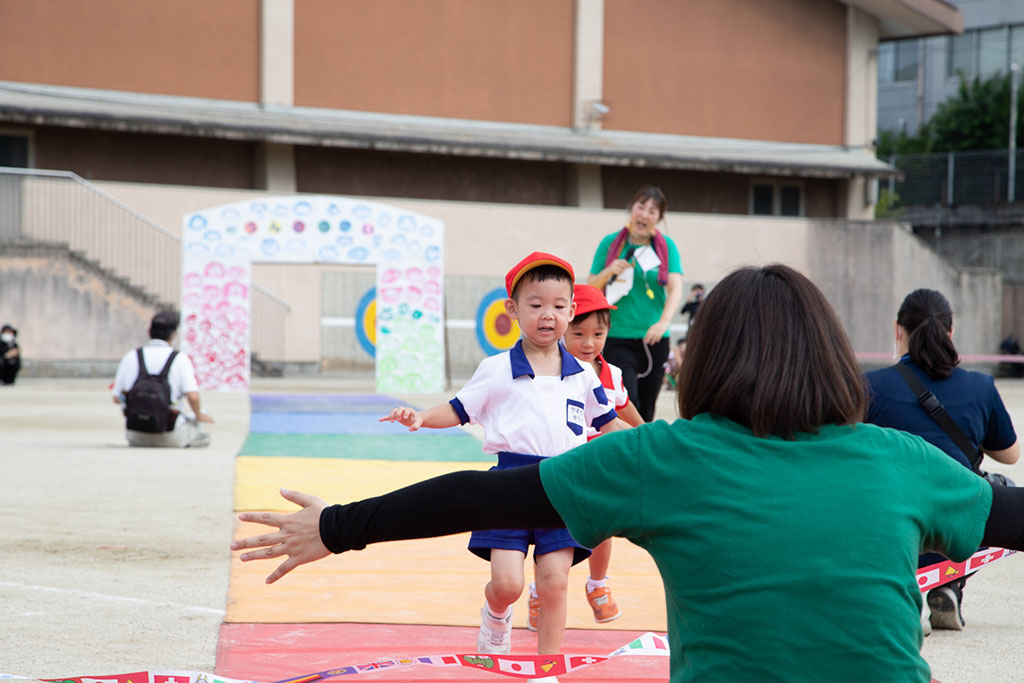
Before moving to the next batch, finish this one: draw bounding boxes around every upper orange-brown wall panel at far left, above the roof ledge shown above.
[0,0,259,101]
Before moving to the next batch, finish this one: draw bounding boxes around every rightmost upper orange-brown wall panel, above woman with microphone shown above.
[603,0,846,144]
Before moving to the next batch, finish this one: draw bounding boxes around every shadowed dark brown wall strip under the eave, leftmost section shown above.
[33,127,256,188]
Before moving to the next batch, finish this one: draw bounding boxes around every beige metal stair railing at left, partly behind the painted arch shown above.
[0,167,291,360]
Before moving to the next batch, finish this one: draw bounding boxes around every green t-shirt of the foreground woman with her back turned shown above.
[541,414,992,683]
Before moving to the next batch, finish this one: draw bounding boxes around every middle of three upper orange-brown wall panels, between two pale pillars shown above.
[295,0,573,126]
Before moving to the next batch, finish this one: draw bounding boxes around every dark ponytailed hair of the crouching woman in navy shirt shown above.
[896,289,959,380]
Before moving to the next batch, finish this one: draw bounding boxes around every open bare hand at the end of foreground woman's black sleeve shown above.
[231,488,331,584]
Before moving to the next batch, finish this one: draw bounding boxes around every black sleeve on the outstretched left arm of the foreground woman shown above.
[319,465,565,553]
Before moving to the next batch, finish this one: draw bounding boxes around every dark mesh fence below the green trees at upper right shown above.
[888,150,1024,207]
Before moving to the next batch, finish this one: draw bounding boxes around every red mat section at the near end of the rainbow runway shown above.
[216,624,669,683]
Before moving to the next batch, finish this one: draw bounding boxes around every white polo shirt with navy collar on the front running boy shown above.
[450,340,615,458]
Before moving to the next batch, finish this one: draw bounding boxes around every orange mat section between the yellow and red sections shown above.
[224,522,667,630]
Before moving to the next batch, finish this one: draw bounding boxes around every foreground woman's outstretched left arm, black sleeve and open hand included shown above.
[231,465,565,584]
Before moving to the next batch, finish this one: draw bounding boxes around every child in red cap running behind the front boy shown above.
[527,285,643,631]
